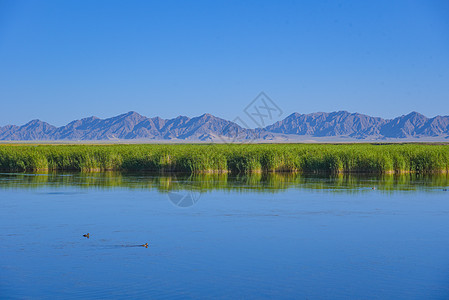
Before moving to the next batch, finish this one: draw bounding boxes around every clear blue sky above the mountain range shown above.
[0,0,449,126]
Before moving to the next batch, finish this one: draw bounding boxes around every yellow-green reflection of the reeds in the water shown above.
[0,172,449,192]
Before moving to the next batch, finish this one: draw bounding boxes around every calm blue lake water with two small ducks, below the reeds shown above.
[0,173,449,299]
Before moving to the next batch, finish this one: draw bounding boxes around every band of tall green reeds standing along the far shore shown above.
[0,144,449,174]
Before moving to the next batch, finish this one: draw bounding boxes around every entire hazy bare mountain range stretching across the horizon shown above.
[0,111,449,142]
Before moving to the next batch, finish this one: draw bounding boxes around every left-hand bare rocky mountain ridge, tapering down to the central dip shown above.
[0,112,273,141]
